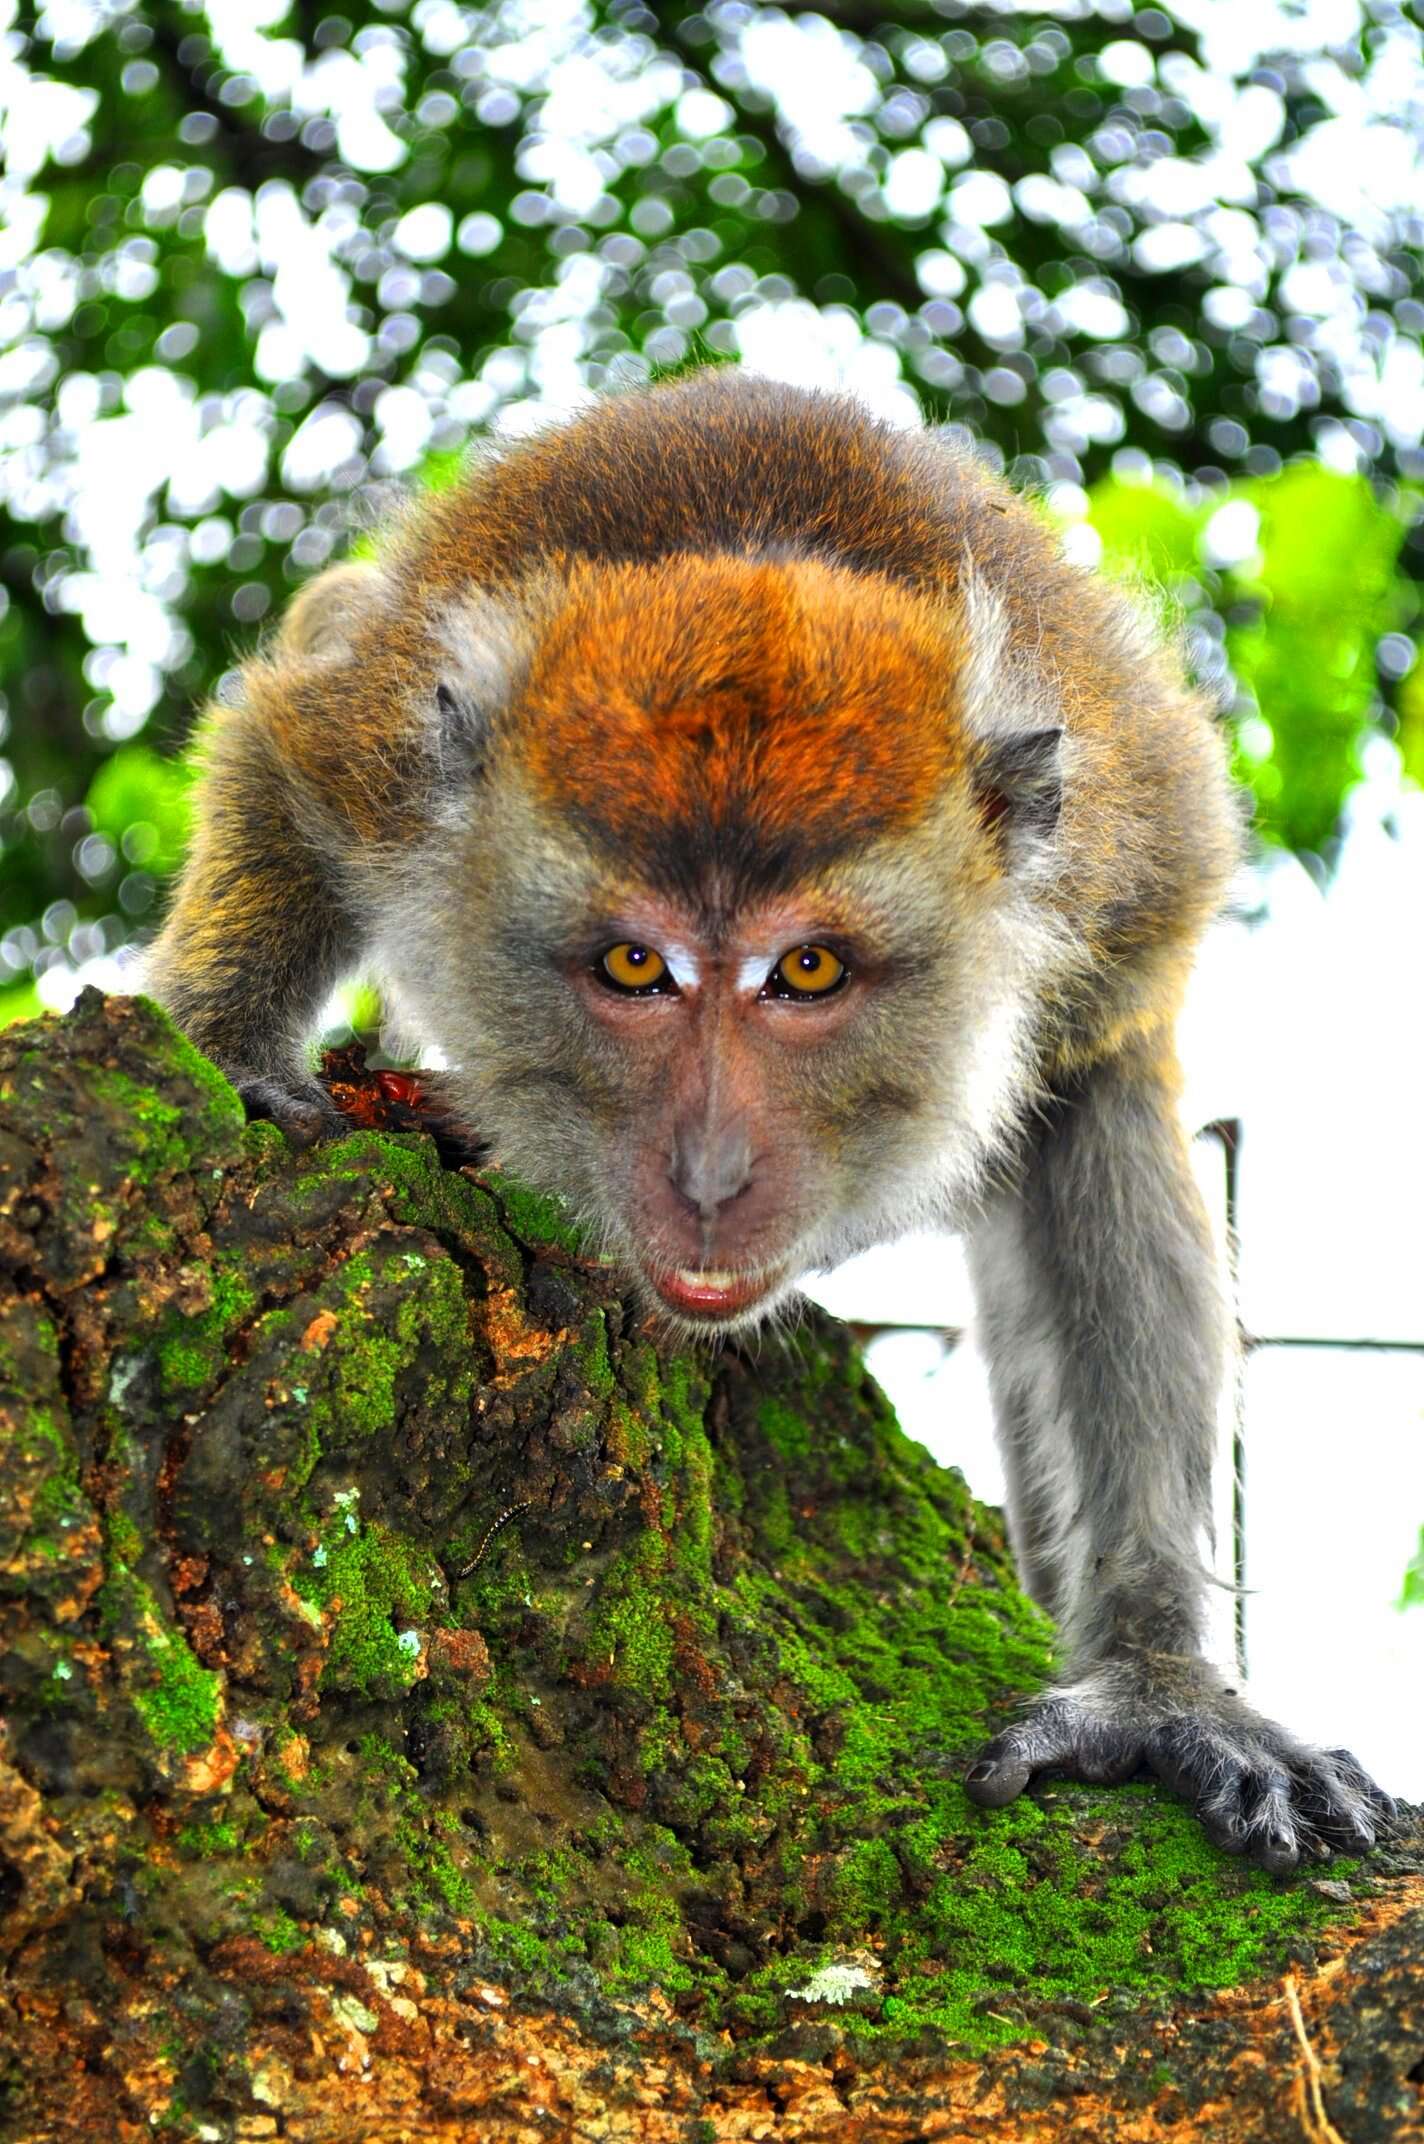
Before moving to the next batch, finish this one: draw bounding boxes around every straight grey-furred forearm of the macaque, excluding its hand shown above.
[971,1037,1229,1659]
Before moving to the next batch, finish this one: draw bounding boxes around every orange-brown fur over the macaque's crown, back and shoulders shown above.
[144,371,1240,1089]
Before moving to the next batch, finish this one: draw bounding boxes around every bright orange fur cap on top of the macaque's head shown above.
[523,555,967,879]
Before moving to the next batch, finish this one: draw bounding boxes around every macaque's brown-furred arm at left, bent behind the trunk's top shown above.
[144,710,358,1145]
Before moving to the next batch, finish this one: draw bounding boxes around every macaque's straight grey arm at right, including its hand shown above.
[967,1044,1394,1872]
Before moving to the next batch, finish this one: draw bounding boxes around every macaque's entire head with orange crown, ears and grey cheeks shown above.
[368,555,1059,1334]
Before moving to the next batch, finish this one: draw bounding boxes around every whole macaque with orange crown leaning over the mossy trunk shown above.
[150,371,1392,1870]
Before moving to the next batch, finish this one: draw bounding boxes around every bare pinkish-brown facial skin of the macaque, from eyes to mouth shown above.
[564,896,888,1327]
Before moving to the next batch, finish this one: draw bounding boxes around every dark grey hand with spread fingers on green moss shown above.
[965,1659,1398,1876]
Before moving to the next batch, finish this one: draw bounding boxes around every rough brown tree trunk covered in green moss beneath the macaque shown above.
[0,993,1424,2144]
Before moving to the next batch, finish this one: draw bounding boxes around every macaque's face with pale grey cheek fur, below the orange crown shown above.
[383,791,1050,1336]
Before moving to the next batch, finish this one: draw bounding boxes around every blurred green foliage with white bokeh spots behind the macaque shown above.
[0,0,1424,1018]
